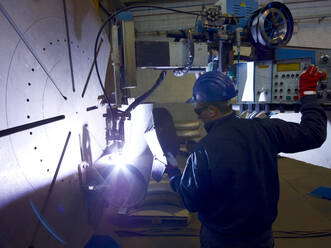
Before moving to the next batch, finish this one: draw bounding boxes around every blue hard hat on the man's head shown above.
[186,71,237,103]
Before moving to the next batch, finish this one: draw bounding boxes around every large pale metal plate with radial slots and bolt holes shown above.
[0,0,110,247]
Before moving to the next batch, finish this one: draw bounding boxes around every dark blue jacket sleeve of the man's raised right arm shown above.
[269,95,327,153]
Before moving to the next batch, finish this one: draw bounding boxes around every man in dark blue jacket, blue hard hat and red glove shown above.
[166,66,327,248]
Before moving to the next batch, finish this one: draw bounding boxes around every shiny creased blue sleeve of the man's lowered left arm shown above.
[170,149,211,212]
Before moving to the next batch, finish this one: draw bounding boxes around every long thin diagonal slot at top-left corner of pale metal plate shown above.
[0,2,67,100]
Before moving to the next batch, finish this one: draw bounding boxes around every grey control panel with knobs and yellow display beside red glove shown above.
[237,50,331,109]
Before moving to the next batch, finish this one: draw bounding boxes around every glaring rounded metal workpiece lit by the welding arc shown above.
[94,104,158,214]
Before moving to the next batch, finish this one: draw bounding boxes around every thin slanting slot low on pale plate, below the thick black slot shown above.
[31,131,71,247]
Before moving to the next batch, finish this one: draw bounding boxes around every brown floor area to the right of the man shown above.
[273,158,331,248]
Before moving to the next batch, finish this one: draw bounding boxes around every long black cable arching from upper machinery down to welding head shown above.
[94,5,200,121]
